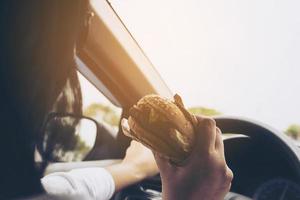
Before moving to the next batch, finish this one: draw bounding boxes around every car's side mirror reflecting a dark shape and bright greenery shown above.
[37,113,98,162]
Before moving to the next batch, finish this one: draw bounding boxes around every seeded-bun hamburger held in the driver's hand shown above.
[122,94,196,164]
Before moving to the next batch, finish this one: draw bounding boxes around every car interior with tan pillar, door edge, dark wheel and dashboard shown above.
[45,0,300,200]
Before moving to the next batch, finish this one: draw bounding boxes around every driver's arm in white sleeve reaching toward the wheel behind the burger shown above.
[42,141,158,200]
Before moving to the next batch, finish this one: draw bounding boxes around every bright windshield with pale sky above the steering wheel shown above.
[110,0,300,134]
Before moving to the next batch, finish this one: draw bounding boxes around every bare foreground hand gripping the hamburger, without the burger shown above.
[155,116,233,200]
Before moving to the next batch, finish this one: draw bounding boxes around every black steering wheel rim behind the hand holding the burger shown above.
[113,117,300,200]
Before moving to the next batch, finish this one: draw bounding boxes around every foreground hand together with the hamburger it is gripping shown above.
[122,95,233,200]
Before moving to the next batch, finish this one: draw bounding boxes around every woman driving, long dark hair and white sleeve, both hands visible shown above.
[0,0,232,199]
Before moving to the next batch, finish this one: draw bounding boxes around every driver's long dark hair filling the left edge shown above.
[0,0,88,199]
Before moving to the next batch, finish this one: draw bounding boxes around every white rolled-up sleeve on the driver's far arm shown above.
[41,167,115,200]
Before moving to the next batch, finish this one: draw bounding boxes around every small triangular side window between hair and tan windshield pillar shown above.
[78,72,122,137]
